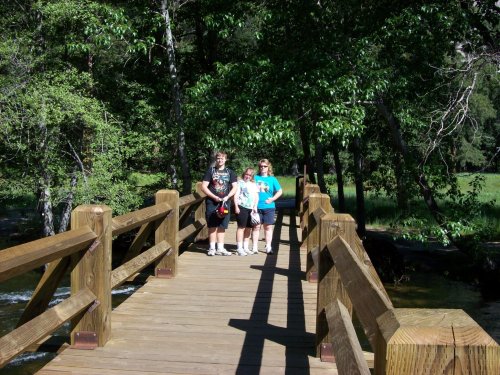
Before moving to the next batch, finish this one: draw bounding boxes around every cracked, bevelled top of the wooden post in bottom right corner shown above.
[375,309,500,375]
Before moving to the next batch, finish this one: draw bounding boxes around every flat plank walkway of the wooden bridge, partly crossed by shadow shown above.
[38,213,337,375]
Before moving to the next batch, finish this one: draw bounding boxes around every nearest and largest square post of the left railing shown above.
[71,205,112,347]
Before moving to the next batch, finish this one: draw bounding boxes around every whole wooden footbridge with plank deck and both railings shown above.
[0,183,500,375]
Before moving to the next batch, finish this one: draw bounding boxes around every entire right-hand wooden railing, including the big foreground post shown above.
[298,180,500,375]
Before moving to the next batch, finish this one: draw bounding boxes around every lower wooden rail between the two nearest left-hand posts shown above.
[111,241,171,289]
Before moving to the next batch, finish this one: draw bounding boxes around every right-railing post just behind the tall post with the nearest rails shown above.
[306,193,333,281]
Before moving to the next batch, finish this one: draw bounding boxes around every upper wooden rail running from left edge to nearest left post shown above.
[0,226,97,281]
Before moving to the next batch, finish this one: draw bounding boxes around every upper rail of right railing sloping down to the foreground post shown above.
[328,236,393,351]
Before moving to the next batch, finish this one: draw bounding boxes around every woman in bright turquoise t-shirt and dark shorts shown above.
[255,159,283,254]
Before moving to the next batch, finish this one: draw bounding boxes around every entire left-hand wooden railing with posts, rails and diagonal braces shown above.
[0,183,206,368]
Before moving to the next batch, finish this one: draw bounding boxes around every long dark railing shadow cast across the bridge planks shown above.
[229,210,314,375]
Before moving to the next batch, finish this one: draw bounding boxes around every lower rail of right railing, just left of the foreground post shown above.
[326,300,370,375]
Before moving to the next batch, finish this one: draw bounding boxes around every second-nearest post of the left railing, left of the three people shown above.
[155,190,179,278]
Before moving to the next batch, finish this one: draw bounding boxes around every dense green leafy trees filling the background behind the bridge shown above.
[0,0,500,280]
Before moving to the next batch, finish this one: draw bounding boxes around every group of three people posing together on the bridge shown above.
[202,151,283,256]
